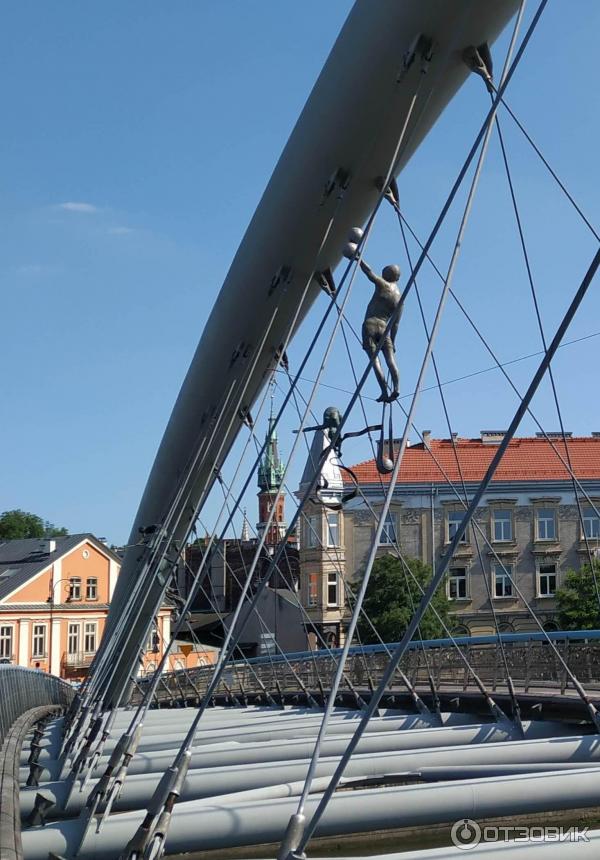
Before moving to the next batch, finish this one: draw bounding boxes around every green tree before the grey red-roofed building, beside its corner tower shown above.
[358,555,450,643]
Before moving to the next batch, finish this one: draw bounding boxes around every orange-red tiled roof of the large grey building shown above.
[351,436,600,484]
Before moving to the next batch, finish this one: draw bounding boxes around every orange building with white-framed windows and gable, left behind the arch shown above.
[0,534,208,681]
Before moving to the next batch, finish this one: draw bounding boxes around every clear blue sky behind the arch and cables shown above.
[0,0,600,543]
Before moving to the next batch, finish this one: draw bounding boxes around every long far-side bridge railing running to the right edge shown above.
[133,631,600,703]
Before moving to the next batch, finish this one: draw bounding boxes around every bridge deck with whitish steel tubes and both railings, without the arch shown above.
[0,631,600,860]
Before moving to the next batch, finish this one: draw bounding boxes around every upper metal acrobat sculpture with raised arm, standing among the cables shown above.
[360,255,402,403]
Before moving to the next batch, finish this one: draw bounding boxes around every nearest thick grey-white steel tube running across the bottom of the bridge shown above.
[23,764,600,860]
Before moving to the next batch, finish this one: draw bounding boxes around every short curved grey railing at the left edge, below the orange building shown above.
[0,664,74,746]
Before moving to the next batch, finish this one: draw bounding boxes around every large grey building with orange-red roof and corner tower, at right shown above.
[300,431,600,640]
